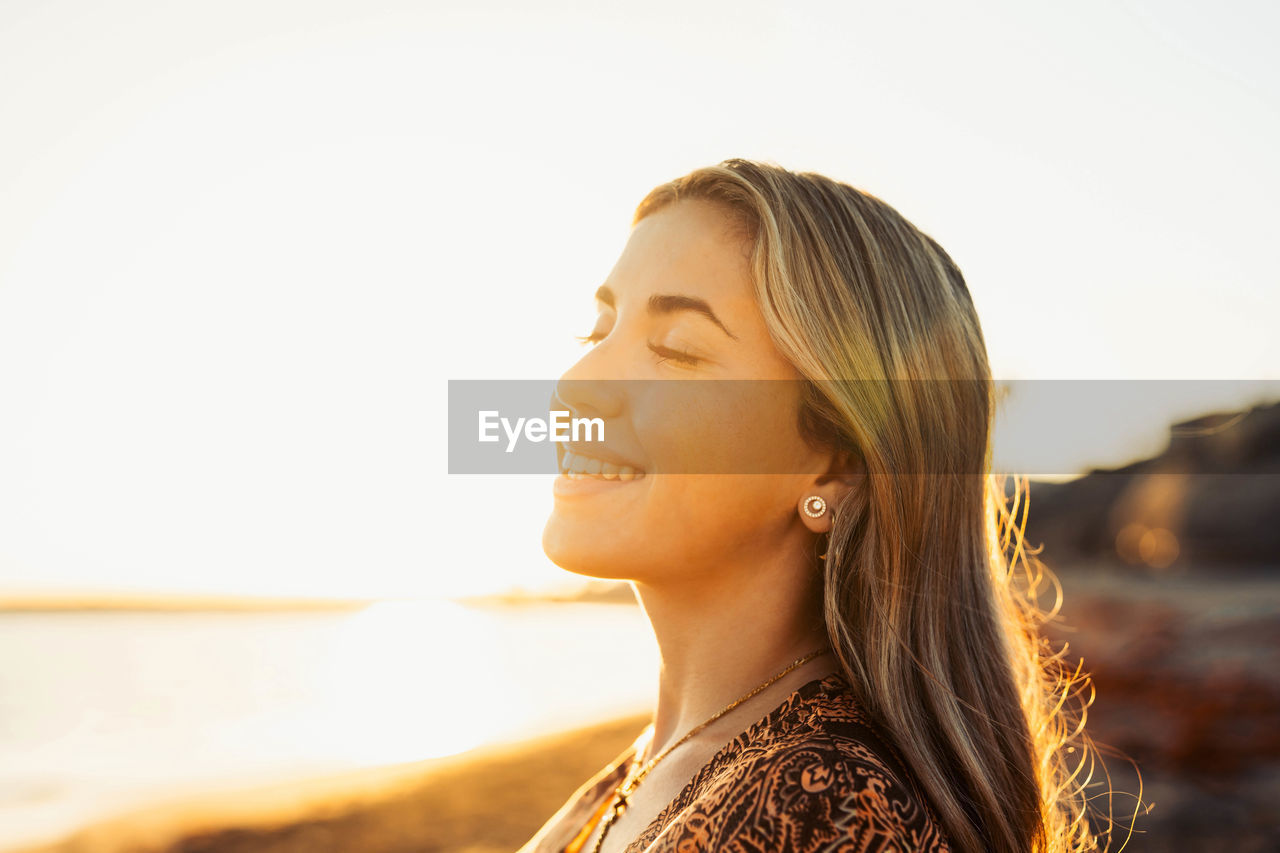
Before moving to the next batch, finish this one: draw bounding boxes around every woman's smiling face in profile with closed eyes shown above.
[543,201,829,584]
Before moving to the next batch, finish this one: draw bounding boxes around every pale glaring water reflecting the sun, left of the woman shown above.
[0,602,657,849]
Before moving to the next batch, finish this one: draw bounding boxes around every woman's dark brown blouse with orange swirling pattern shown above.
[520,672,950,853]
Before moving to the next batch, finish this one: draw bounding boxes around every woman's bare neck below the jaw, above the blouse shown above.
[636,561,835,756]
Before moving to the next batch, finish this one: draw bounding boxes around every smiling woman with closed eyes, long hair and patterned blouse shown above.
[524,160,1097,853]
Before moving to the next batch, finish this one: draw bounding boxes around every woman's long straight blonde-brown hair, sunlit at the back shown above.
[635,160,1098,853]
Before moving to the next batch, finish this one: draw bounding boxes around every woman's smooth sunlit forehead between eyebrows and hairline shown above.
[608,201,755,306]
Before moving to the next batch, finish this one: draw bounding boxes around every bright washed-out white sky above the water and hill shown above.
[0,0,1280,597]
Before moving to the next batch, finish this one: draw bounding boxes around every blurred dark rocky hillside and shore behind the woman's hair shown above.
[1027,405,1280,850]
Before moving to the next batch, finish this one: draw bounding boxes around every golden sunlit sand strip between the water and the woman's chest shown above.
[24,716,648,853]
